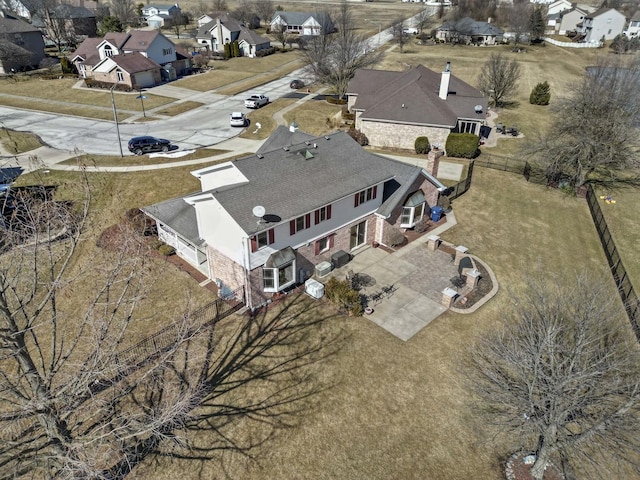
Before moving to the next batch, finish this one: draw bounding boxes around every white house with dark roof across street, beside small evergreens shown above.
[196,13,271,57]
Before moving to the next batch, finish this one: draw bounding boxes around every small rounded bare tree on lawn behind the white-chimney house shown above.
[478,53,521,106]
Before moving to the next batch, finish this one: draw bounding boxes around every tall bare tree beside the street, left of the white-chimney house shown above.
[302,1,382,98]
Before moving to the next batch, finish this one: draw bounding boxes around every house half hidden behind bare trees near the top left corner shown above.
[31,4,97,43]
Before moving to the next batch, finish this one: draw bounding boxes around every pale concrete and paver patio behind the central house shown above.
[320,212,458,341]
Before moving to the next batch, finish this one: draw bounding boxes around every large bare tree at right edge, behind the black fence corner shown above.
[528,58,640,188]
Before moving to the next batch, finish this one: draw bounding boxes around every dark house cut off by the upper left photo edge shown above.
[0,11,45,74]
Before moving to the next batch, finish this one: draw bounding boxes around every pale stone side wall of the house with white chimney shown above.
[356,119,451,150]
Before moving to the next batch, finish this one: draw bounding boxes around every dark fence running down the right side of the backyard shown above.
[587,185,640,341]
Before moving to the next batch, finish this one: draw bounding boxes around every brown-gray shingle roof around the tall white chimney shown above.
[347,65,488,128]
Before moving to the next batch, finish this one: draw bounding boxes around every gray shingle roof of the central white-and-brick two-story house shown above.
[143,129,436,241]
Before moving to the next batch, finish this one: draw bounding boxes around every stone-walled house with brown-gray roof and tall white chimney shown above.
[347,63,488,150]
